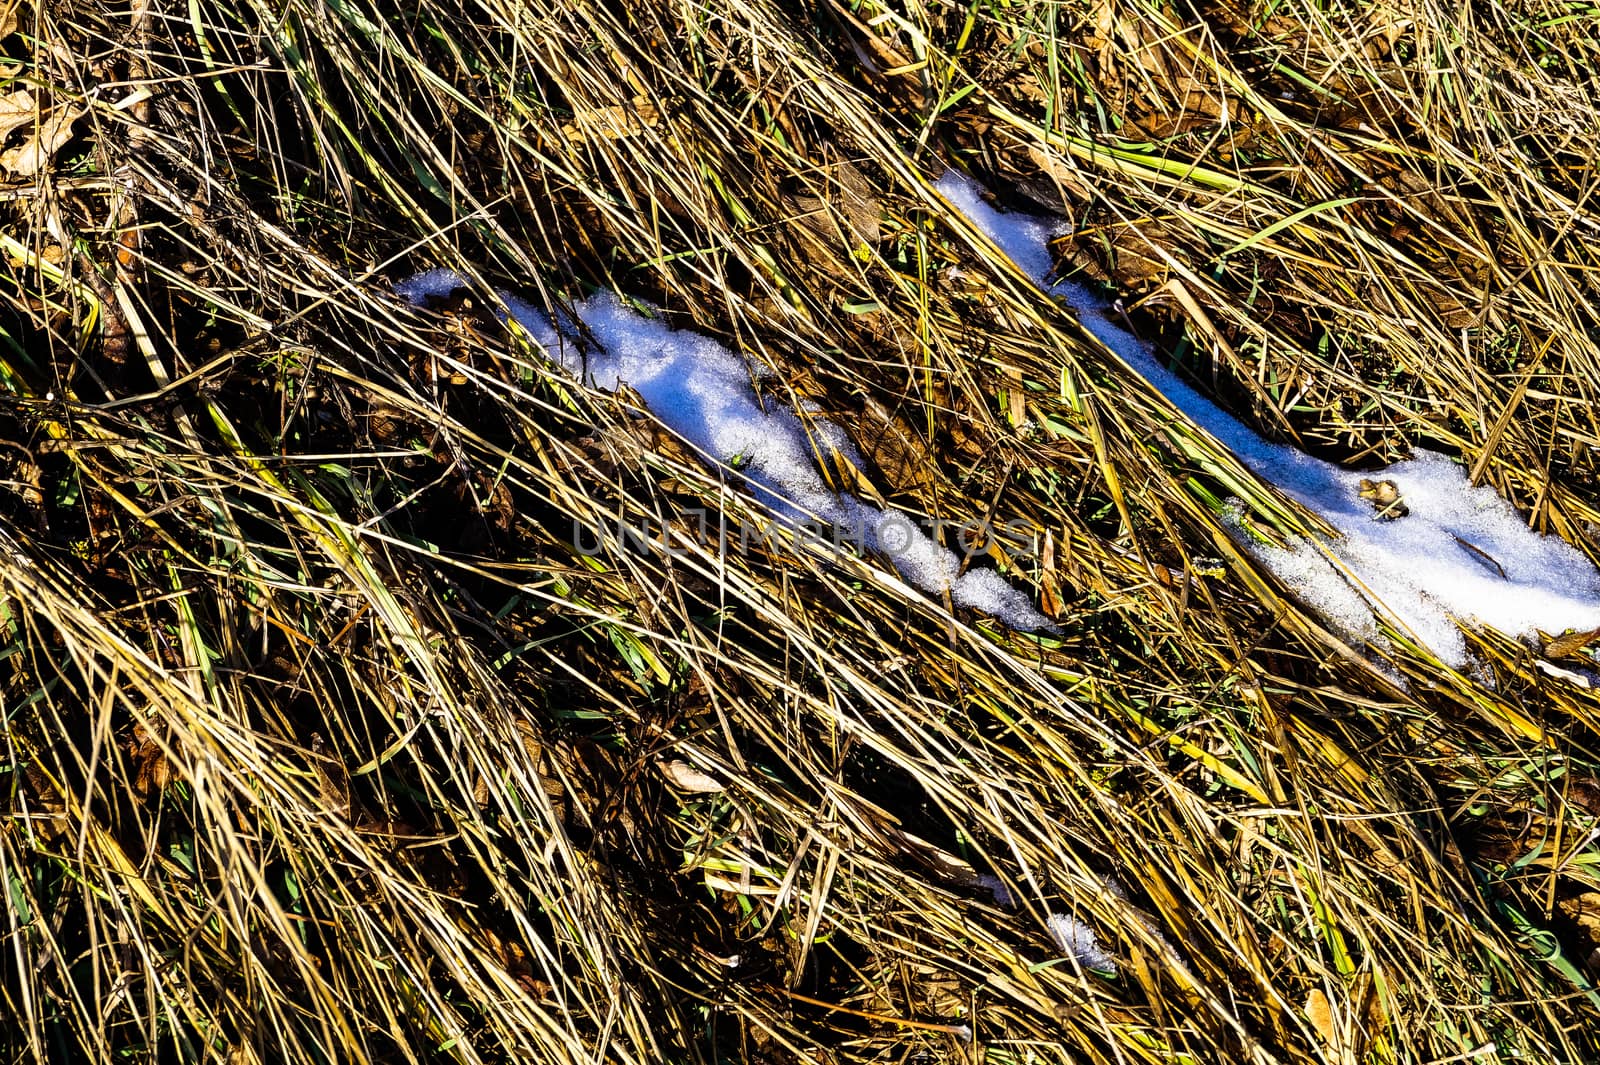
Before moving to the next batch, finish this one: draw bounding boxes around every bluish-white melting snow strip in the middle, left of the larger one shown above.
[395,269,1053,632]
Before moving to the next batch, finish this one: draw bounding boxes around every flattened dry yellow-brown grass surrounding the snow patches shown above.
[0,0,1600,1065]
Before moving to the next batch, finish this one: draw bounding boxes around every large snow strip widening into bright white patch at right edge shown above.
[936,171,1600,668]
